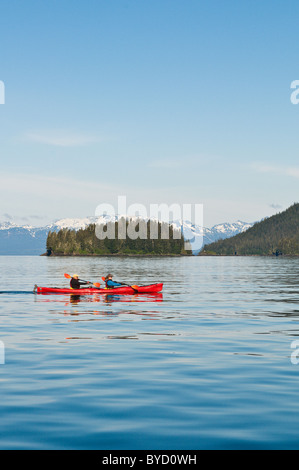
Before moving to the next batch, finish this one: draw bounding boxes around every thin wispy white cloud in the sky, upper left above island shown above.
[24,130,102,147]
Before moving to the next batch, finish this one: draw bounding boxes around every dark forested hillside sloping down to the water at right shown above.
[200,204,299,255]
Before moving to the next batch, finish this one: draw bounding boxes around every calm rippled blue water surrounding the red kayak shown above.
[0,256,299,450]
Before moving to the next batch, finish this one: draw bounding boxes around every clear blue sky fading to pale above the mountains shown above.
[0,0,299,226]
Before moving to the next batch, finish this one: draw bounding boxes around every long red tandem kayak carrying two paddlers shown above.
[34,283,163,295]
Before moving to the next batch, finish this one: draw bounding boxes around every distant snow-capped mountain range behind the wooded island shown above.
[0,216,253,255]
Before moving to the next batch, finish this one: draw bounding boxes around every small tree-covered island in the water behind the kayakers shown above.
[47,219,190,255]
